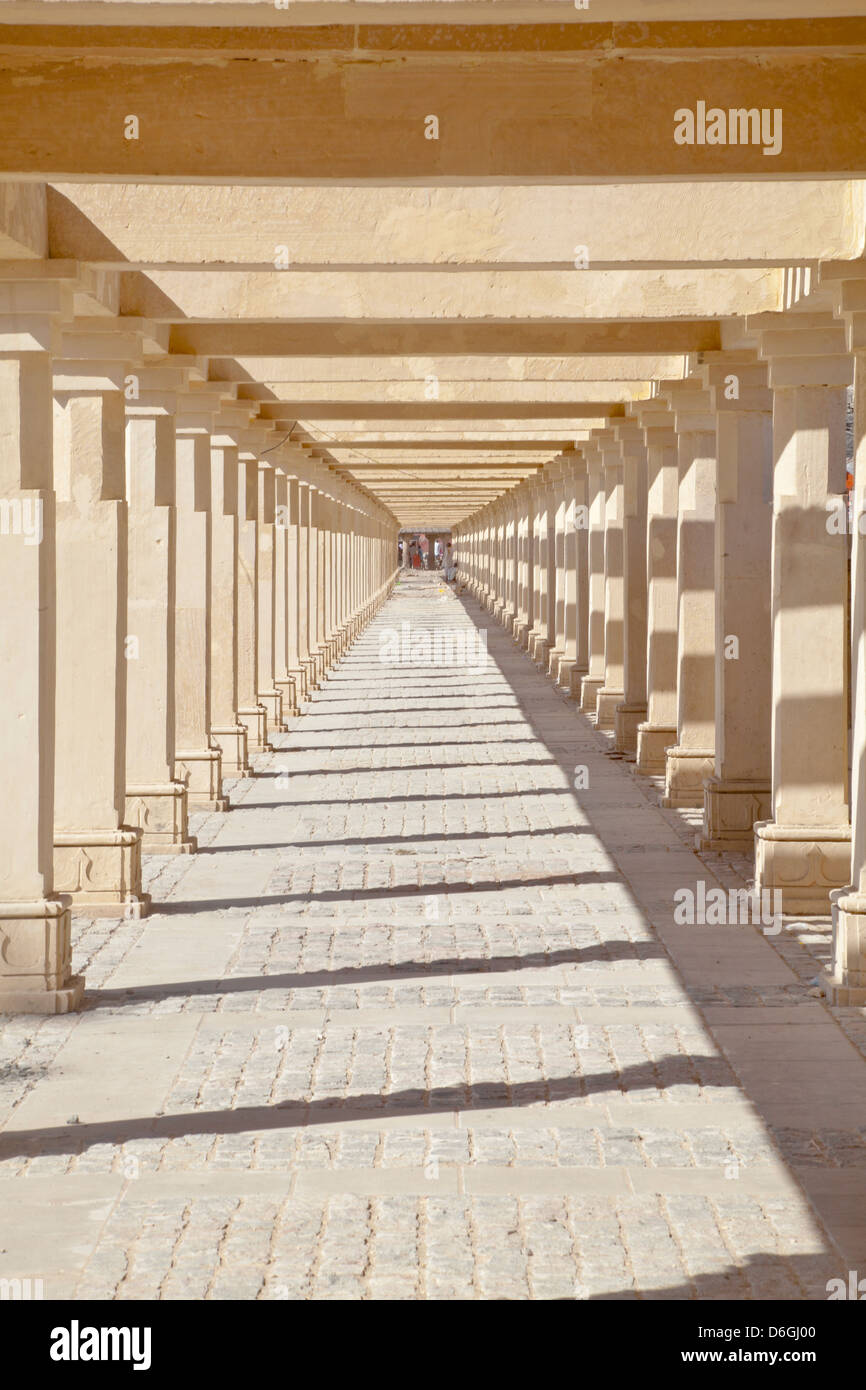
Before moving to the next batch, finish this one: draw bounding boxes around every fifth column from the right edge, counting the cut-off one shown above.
[635,399,680,777]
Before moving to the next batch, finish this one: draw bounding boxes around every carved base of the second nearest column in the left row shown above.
[54,826,150,917]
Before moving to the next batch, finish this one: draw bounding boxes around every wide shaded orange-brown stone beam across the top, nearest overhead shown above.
[0,27,866,182]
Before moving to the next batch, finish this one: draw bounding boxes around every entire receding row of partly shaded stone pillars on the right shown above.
[455,314,866,1004]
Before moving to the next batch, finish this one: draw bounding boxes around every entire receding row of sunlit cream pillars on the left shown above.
[0,285,396,1013]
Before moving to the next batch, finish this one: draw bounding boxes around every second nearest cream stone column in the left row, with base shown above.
[50,358,149,917]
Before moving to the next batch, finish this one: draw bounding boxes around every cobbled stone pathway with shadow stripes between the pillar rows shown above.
[0,574,866,1298]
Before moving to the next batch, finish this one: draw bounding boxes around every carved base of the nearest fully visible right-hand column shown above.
[755,820,851,917]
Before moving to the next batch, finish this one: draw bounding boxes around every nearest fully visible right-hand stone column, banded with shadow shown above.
[755,333,852,915]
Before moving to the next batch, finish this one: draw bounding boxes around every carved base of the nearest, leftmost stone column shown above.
[0,898,85,1013]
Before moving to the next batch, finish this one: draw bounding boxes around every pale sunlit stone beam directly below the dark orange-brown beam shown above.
[47,179,865,272]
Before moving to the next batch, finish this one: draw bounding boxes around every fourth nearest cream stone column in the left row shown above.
[174,422,229,810]
